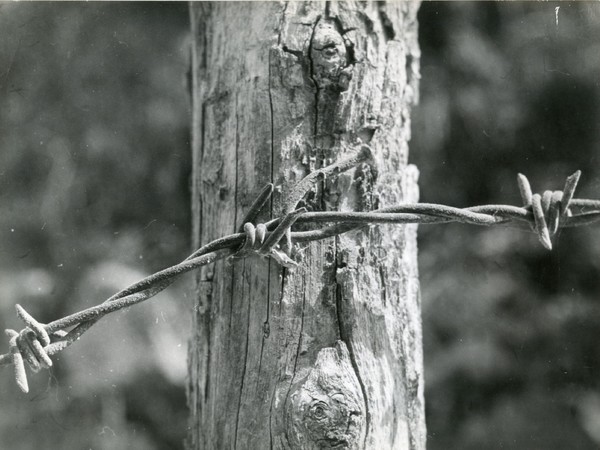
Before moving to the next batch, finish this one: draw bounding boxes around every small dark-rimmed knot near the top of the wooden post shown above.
[310,20,352,91]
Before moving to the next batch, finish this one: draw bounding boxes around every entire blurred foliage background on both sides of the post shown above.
[0,2,600,450]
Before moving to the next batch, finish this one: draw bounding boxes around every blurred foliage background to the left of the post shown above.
[0,3,190,450]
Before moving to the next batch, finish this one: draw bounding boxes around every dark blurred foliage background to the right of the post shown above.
[411,2,600,450]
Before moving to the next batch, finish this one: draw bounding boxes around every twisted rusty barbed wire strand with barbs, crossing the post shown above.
[0,145,600,392]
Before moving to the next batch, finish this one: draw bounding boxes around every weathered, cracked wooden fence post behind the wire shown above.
[188,2,425,450]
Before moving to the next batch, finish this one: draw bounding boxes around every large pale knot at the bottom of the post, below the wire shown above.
[286,341,365,449]
